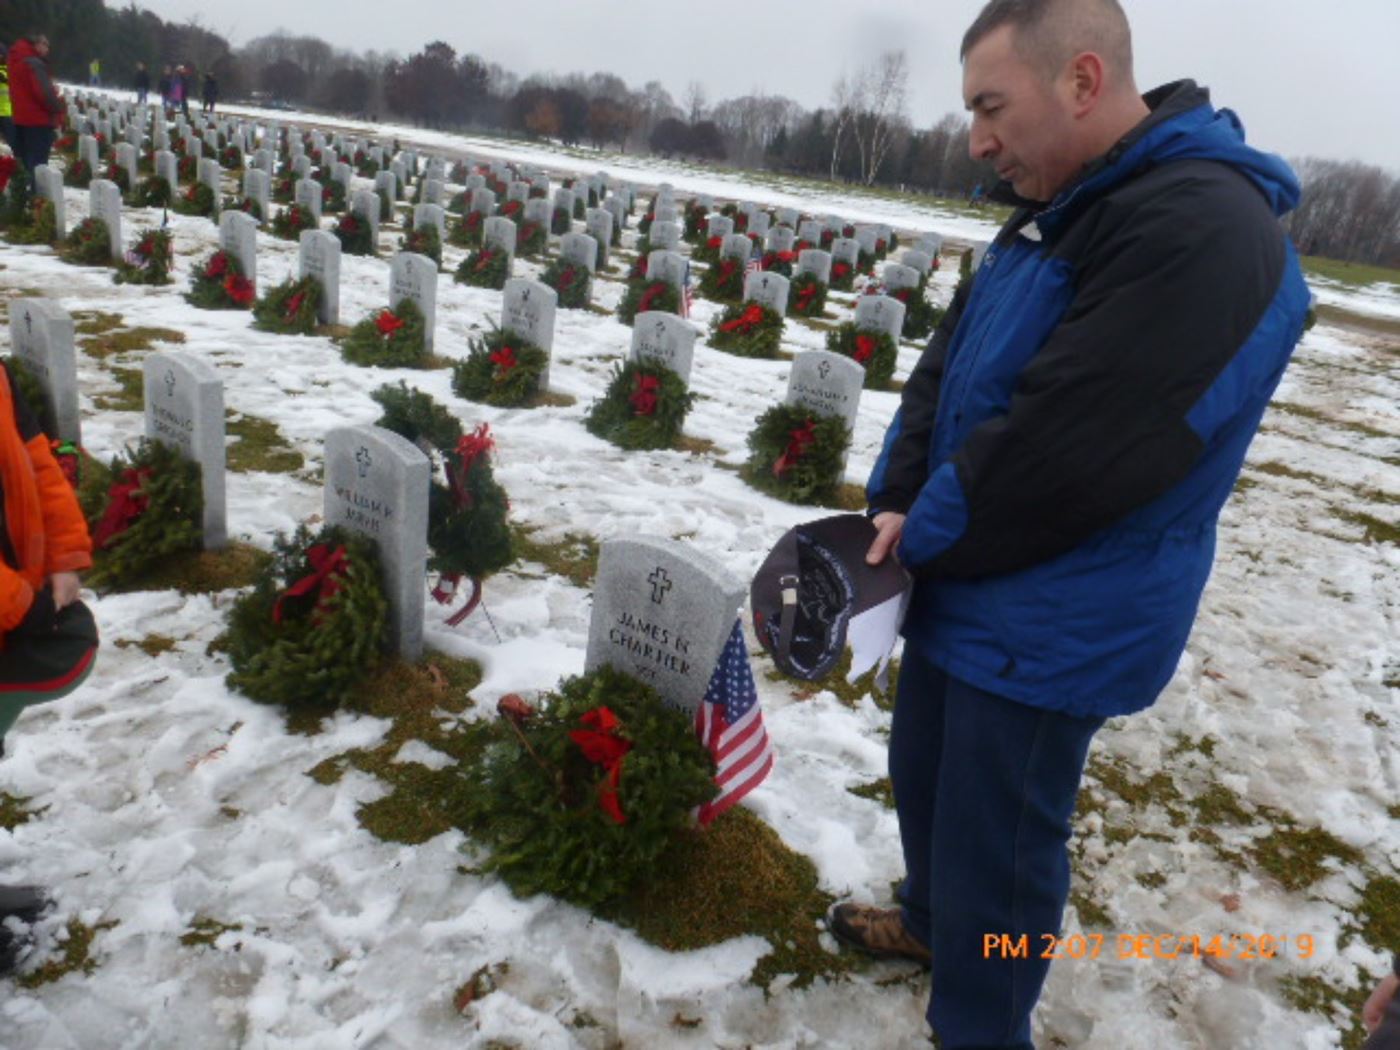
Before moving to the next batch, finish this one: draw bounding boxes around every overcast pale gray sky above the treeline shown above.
[128,0,1400,171]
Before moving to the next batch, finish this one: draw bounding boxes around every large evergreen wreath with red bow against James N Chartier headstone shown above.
[461,666,717,909]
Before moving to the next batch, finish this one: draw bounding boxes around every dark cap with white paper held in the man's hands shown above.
[750,514,910,680]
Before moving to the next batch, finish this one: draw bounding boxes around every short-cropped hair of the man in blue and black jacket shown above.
[959,0,1133,83]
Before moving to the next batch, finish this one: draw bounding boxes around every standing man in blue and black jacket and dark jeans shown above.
[830,0,1308,1050]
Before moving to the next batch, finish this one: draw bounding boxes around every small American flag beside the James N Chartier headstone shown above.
[696,620,773,826]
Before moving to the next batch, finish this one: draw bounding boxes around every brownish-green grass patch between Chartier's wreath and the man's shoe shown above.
[605,806,857,987]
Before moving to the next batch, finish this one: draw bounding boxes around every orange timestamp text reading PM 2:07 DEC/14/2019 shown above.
[981,932,1317,960]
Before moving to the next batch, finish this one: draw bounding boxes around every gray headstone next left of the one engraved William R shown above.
[141,353,228,550]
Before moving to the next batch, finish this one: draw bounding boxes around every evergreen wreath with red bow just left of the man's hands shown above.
[745,405,851,503]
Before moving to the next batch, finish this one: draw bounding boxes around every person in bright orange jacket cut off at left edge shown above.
[0,364,97,974]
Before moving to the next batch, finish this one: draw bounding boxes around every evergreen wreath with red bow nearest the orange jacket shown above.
[87,438,204,589]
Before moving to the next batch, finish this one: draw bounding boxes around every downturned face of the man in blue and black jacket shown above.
[963,25,1088,200]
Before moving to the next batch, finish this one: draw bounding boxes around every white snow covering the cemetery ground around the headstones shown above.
[0,113,1400,1050]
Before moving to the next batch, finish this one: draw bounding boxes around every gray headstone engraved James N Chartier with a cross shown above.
[585,538,745,715]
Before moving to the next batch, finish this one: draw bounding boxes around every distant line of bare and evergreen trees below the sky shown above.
[0,0,1400,266]
